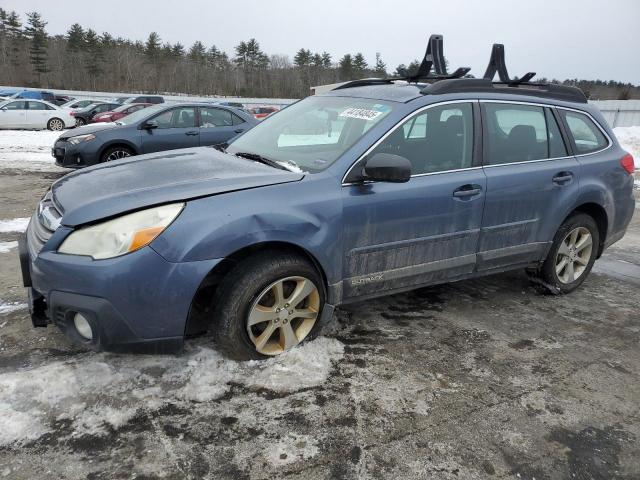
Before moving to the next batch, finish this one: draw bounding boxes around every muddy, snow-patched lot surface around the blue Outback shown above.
[0,170,640,480]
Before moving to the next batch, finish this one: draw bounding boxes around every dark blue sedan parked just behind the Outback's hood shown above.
[52,103,258,168]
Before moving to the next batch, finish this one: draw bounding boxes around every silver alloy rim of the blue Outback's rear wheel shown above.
[556,227,593,284]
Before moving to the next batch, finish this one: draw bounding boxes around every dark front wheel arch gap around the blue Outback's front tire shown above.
[185,241,329,336]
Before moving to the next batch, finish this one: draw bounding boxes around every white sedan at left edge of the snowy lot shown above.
[0,99,76,131]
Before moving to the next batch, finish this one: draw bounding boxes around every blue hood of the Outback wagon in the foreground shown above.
[51,147,304,227]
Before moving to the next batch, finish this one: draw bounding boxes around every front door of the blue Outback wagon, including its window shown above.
[342,102,486,299]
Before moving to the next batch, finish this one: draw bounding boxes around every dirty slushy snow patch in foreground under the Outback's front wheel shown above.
[0,337,344,446]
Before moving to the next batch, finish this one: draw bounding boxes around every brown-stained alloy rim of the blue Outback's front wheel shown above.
[247,277,320,355]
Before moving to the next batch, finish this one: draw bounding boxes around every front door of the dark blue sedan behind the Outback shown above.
[141,107,200,153]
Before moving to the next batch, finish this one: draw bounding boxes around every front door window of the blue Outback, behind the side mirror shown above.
[369,103,473,175]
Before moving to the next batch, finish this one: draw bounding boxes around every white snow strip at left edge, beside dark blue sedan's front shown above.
[0,130,62,171]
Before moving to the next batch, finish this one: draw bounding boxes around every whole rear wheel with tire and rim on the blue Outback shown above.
[527,213,600,295]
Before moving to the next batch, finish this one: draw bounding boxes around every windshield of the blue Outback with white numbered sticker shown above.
[228,97,393,173]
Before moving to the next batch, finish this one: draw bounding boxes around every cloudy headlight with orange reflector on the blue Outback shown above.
[58,203,184,260]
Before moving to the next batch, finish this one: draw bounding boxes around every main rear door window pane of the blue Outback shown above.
[484,103,549,165]
